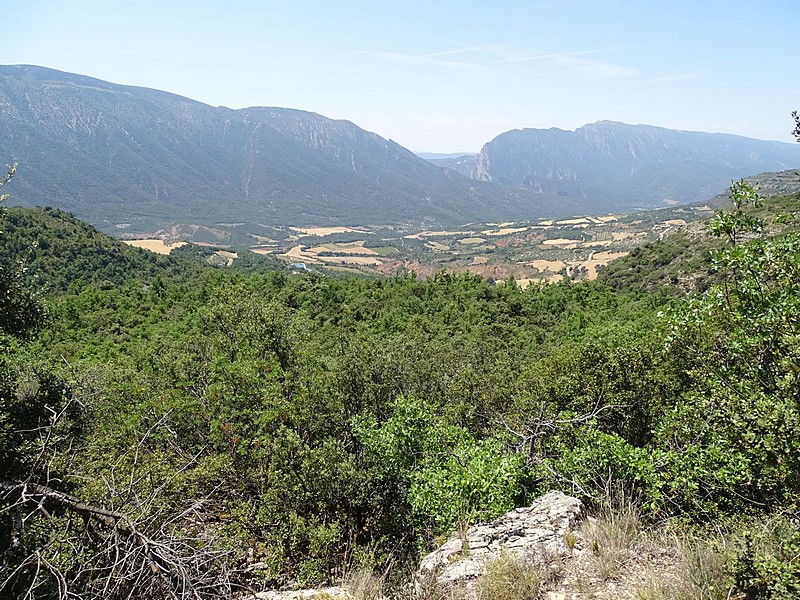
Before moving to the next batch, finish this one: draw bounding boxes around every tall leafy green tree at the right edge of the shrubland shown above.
[656,177,800,513]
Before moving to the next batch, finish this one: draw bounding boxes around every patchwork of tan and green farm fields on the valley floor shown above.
[236,206,712,287]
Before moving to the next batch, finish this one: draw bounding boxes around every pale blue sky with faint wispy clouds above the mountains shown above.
[0,0,800,153]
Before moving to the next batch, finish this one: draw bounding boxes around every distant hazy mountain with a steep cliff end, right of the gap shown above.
[473,121,800,211]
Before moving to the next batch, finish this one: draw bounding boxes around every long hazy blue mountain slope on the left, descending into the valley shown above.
[0,66,571,232]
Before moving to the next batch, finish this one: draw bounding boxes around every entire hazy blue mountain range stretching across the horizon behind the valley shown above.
[0,65,800,237]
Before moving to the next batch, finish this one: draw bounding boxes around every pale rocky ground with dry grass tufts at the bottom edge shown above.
[241,491,682,600]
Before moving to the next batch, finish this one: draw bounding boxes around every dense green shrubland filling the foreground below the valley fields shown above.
[0,166,800,598]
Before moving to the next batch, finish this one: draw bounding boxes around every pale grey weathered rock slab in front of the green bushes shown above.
[416,491,586,591]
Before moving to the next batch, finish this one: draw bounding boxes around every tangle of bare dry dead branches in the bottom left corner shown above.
[0,481,239,600]
